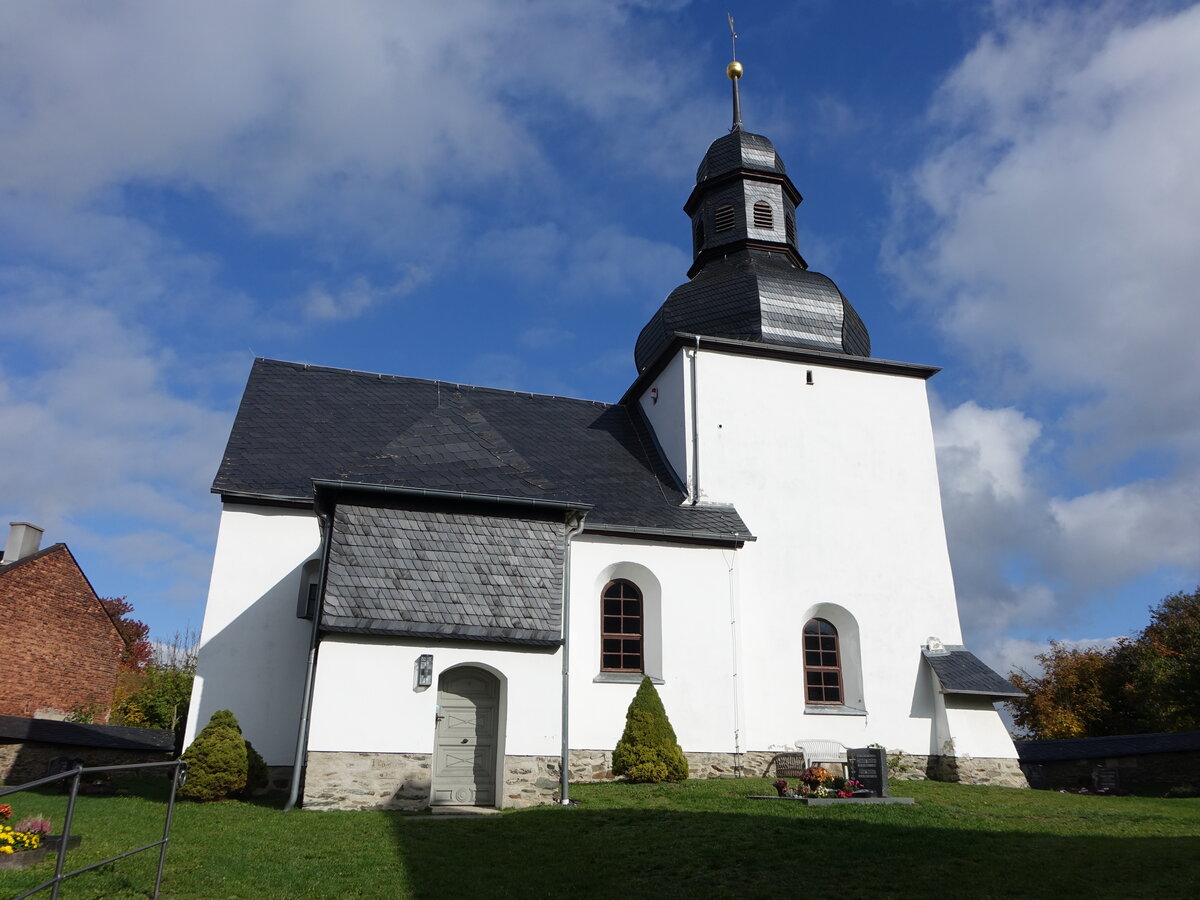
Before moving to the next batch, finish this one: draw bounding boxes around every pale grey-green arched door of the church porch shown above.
[432,666,500,806]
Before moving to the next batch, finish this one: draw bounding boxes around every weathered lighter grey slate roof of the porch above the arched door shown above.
[322,504,565,644]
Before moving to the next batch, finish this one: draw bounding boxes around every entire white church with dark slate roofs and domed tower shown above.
[187,62,1025,809]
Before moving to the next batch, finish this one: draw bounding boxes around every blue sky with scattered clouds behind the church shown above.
[0,0,1200,667]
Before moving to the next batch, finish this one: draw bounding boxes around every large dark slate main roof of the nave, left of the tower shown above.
[212,359,752,540]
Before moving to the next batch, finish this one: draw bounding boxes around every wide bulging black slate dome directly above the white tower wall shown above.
[634,250,871,372]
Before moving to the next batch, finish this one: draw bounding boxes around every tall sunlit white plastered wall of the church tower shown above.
[638,350,1015,757]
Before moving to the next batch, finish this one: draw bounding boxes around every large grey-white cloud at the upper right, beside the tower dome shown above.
[893,0,1200,462]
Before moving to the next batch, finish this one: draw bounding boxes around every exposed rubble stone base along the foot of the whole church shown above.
[295,750,1028,810]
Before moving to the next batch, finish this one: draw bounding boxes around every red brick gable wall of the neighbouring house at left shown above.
[0,544,121,716]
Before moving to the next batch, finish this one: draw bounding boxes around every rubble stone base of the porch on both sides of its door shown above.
[304,751,559,810]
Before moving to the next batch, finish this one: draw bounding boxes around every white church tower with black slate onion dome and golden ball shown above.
[624,54,1022,784]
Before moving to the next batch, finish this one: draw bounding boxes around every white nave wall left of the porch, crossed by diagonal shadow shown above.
[185,504,320,766]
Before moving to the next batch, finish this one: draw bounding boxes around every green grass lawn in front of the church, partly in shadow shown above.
[0,779,1200,900]
